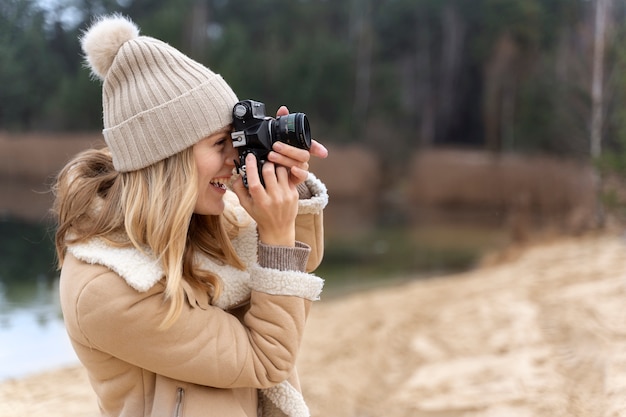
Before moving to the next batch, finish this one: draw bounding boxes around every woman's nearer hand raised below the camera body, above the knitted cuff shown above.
[232,154,298,246]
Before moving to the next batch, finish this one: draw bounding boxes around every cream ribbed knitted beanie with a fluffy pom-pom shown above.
[81,15,238,172]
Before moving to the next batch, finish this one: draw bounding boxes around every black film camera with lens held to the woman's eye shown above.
[231,100,311,187]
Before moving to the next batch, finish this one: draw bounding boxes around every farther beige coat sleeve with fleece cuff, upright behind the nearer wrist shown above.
[296,173,328,272]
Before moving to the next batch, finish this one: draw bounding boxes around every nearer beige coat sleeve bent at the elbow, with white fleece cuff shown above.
[62,255,322,388]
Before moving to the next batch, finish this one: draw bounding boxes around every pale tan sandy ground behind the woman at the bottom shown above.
[0,235,626,417]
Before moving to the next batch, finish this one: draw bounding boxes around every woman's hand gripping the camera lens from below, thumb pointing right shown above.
[268,106,328,185]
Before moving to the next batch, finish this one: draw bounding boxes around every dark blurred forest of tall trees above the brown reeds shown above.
[0,0,626,170]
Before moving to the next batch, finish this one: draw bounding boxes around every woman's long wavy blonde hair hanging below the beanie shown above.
[53,147,244,328]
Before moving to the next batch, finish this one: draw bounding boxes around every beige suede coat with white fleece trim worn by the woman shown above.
[61,176,328,417]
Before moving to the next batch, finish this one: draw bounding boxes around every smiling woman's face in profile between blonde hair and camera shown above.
[193,127,237,215]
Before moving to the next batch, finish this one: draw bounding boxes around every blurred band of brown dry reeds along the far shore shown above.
[0,132,597,241]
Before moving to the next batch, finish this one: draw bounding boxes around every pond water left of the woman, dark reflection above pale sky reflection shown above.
[0,218,78,381]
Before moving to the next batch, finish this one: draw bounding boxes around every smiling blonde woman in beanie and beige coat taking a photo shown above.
[54,16,328,417]
